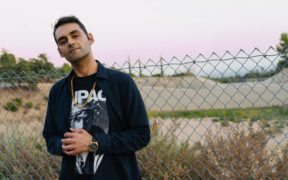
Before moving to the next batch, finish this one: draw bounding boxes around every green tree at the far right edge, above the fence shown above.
[276,33,288,72]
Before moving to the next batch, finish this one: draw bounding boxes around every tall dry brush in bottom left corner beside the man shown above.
[0,134,61,179]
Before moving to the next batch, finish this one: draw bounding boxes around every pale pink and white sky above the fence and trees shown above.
[0,0,288,66]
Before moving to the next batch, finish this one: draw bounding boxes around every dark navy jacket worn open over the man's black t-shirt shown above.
[43,62,150,180]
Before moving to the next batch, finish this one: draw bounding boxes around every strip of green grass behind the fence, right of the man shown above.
[148,106,288,134]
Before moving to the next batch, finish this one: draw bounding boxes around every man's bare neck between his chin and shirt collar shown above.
[72,58,98,77]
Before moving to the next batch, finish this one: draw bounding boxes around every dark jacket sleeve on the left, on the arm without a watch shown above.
[43,87,63,156]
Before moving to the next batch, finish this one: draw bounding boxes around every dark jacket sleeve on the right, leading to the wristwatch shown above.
[93,75,150,154]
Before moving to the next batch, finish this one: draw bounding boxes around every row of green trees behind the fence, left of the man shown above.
[0,50,71,88]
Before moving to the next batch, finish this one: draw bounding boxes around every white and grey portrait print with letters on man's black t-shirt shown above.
[70,90,109,174]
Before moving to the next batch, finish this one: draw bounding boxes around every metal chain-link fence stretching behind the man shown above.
[0,47,288,179]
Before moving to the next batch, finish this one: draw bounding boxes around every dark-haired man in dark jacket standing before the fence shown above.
[43,16,150,180]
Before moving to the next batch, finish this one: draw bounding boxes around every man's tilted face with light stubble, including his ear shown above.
[55,23,94,63]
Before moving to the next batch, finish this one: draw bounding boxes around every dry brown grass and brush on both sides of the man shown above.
[0,84,288,179]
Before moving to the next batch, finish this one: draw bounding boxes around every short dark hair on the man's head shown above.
[53,16,88,44]
